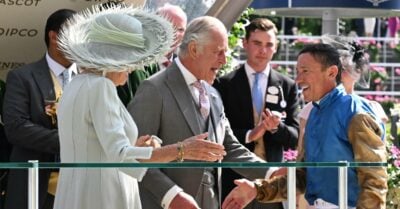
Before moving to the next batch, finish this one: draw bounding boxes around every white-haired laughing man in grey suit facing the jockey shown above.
[128,16,274,209]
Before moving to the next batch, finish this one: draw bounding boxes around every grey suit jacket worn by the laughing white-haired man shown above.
[128,63,266,209]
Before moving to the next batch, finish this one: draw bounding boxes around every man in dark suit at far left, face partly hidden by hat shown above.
[3,9,76,209]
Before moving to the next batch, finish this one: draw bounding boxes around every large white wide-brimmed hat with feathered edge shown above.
[59,5,174,71]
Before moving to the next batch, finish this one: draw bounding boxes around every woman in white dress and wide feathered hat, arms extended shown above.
[54,3,225,209]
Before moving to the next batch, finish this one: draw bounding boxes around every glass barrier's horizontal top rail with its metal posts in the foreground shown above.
[0,160,387,209]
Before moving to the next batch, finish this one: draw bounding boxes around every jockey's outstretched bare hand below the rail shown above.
[222,179,257,209]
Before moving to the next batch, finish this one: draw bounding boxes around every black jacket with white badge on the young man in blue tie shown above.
[214,65,299,198]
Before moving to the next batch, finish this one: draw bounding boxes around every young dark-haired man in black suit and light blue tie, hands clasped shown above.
[214,18,299,208]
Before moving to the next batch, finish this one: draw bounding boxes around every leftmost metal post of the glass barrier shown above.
[28,160,39,209]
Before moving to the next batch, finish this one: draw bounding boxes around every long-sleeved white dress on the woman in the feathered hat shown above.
[54,74,152,209]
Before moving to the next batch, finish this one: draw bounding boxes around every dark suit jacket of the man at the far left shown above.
[3,58,60,209]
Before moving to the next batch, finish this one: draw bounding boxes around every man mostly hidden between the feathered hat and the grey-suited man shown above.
[117,4,187,106]
